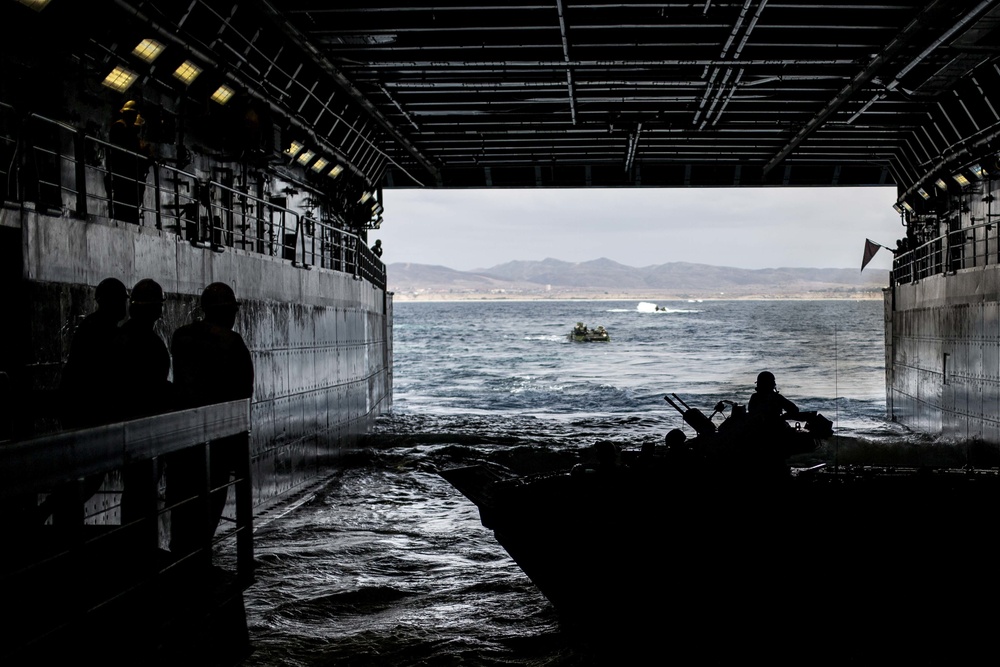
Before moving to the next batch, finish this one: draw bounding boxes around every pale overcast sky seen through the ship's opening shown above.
[376,187,905,271]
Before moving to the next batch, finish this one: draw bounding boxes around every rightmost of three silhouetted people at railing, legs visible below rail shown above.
[167,283,254,553]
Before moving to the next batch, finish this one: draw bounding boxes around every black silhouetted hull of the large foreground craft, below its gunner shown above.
[441,461,1000,664]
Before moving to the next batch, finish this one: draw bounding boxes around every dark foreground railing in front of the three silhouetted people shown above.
[0,400,253,664]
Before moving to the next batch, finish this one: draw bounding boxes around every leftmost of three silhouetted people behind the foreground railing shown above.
[59,278,128,427]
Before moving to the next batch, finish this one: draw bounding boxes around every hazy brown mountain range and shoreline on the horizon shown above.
[387,258,889,300]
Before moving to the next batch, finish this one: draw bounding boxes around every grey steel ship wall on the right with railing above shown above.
[885,170,1000,466]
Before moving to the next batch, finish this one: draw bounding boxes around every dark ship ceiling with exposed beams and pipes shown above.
[262,0,1000,188]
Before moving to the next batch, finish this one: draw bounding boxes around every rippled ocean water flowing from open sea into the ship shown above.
[240,301,914,667]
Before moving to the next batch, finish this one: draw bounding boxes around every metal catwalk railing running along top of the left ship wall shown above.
[0,103,385,289]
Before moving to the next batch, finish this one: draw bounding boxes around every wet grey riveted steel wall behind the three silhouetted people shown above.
[0,208,392,506]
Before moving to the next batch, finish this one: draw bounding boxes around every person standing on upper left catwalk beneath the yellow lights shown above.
[108,100,151,224]
